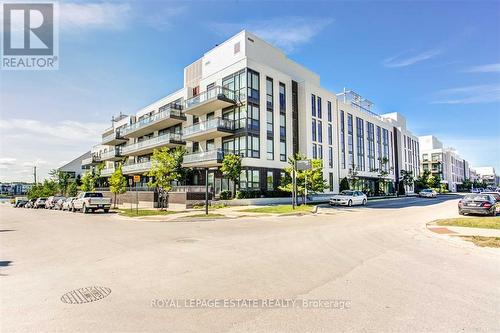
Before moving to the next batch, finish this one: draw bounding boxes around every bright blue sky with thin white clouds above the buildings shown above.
[0,1,500,181]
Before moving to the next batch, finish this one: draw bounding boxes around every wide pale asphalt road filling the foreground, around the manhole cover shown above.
[0,197,500,332]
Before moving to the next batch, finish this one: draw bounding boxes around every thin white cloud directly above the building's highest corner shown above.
[212,17,334,52]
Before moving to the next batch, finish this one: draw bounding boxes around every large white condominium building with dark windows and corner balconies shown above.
[86,31,418,194]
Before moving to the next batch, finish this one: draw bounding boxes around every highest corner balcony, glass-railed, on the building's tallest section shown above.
[185,86,237,117]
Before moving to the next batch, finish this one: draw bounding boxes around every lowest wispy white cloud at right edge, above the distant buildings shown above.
[431,84,500,104]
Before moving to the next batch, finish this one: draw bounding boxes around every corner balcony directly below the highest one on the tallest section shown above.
[183,118,234,141]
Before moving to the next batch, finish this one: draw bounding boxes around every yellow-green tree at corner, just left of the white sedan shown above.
[278,154,327,201]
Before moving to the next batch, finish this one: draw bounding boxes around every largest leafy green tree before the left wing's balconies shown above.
[148,147,186,192]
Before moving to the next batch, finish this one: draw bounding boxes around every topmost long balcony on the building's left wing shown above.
[120,104,186,138]
